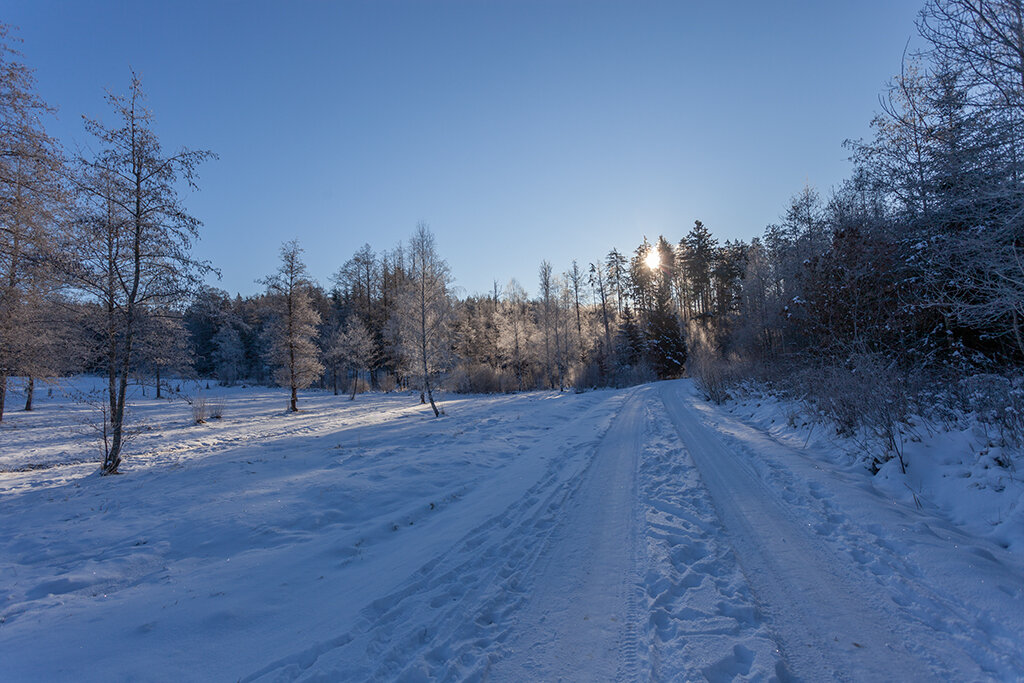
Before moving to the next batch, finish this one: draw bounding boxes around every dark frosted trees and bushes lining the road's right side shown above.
[691,0,1024,465]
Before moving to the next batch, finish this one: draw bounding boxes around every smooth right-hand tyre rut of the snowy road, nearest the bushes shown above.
[662,385,1020,681]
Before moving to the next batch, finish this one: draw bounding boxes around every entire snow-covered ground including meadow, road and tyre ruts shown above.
[0,381,1024,681]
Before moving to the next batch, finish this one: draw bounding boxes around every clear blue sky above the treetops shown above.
[0,0,923,294]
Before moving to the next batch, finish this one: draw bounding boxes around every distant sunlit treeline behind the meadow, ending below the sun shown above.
[184,231,707,399]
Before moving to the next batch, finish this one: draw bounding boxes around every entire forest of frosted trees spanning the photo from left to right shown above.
[0,0,1024,472]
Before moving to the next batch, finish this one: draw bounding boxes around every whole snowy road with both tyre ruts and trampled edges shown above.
[245,382,1024,681]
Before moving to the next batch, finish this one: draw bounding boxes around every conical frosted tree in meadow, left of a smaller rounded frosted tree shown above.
[260,240,324,413]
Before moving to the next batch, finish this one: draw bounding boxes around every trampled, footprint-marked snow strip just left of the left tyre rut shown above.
[242,393,623,681]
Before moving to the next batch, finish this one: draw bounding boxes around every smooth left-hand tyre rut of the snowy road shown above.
[488,389,644,681]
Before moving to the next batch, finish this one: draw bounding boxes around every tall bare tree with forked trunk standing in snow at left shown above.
[65,74,214,474]
